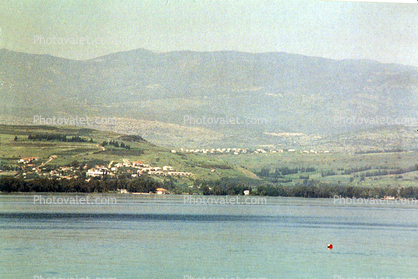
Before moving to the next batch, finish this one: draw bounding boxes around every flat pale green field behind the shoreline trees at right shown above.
[219,151,418,187]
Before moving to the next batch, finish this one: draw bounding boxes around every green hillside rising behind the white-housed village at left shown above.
[0,125,256,188]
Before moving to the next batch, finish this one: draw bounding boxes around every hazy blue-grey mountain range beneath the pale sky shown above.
[0,49,418,149]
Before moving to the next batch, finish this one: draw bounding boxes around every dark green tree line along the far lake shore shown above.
[0,177,418,199]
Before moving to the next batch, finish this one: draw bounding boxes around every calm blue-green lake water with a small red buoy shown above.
[0,194,418,279]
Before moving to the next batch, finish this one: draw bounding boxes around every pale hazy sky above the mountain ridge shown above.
[0,0,418,66]
